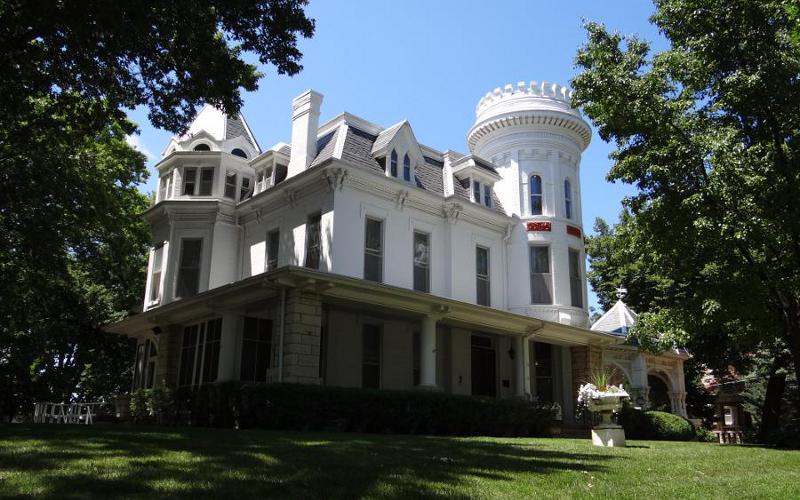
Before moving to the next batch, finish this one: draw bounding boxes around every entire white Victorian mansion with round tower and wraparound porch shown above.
[109,82,686,419]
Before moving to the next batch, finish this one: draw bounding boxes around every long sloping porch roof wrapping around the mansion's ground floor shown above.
[105,266,624,345]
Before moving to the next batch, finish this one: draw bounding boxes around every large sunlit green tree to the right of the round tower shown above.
[573,0,800,436]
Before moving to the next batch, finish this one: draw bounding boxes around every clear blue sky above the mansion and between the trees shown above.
[130,0,664,312]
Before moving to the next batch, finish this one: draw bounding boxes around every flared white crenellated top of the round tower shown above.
[467,80,592,152]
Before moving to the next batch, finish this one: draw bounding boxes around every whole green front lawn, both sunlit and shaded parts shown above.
[0,425,800,500]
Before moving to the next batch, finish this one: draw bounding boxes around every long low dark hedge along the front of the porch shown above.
[162,382,554,436]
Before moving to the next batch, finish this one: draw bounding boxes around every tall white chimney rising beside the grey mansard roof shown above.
[286,90,322,178]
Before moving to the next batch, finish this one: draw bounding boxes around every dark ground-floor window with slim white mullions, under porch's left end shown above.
[178,318,222,387]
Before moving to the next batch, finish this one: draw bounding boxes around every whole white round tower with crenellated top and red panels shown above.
[467,81,591,327]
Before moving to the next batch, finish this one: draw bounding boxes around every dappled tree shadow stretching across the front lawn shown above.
[0,426,621,498]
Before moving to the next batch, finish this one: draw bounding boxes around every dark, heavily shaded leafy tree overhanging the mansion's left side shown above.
[0,0,314,415]
